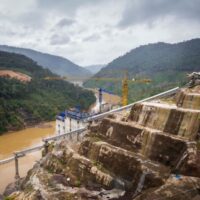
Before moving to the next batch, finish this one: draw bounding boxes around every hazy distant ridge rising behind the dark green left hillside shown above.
[0,45,91,78]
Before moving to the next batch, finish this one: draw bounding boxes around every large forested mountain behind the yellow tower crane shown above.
[84,39,200,102]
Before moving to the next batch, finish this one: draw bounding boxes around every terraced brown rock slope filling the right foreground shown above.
[4,86,200,200]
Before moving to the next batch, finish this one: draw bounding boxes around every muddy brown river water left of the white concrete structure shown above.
[0,122,55,193]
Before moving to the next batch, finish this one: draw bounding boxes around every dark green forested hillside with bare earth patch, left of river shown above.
[0,51,95,133]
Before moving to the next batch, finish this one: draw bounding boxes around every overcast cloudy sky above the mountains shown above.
[0,0,200,66]
